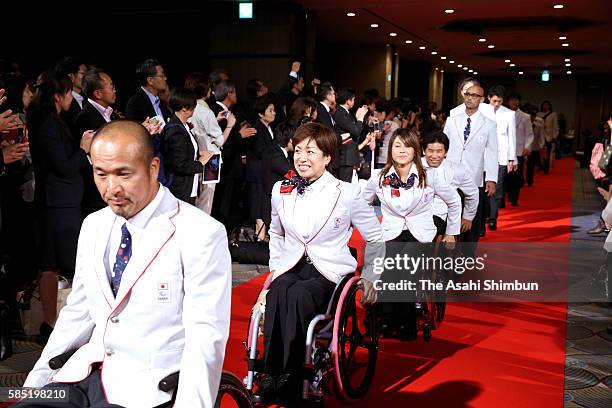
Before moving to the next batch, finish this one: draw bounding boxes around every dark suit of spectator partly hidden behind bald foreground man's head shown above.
[76,102,119,218]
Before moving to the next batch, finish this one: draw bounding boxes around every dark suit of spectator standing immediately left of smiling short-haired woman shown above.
[246,120,273,220]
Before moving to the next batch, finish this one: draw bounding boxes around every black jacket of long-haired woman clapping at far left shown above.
[29,116,89,208]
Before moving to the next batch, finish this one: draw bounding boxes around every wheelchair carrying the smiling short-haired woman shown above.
[244,273,378,406]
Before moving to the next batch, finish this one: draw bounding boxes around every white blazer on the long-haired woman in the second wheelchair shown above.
[363,164,461,242]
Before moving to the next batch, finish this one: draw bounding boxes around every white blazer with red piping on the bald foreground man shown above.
[24,186,232,408]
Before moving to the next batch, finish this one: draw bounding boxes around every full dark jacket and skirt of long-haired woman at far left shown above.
[29,115,89,277]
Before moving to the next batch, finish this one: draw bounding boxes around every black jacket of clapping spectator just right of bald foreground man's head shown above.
[161,115,204,201]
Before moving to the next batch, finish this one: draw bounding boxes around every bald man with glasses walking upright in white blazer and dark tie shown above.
[444,85,498,254]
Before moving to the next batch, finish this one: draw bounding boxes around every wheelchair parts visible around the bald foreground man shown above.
[49,349,253,408]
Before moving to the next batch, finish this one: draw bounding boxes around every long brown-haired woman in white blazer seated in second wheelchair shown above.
[363,129,461,340]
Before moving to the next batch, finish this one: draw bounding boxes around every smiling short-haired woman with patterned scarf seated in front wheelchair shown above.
[255,123,384,402]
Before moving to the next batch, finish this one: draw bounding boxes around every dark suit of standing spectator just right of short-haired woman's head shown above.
[333,106,363,183]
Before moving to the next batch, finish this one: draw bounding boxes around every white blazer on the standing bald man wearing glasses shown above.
[444,111,498,187]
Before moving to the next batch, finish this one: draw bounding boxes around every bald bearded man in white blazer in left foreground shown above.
[18,121,231,408]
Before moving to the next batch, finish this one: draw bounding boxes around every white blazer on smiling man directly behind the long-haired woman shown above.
[421,157,478,221]
